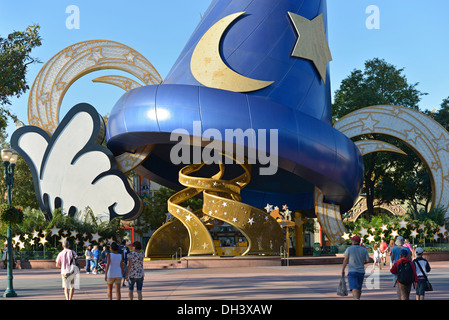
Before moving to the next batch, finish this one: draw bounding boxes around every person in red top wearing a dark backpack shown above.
[390,249,418,300]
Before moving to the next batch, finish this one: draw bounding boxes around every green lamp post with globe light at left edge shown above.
[1,149,18,298]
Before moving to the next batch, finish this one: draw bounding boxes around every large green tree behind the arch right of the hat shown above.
[332,58,425,215]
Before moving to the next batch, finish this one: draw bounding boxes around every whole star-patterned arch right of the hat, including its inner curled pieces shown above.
[315,105,449,242]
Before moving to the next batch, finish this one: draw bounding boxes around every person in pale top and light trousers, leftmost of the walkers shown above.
[56,241,79,300]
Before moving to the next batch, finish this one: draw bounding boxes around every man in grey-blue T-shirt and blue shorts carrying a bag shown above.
[341,236,370,300]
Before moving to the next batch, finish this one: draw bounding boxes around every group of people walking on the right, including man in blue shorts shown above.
[342,236,431,300]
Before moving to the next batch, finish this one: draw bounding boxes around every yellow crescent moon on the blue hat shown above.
[190,12,273,92]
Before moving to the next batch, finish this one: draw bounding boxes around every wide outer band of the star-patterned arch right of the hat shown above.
[334,105,449,218]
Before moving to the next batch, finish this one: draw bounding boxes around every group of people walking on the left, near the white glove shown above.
[56,241,145,300]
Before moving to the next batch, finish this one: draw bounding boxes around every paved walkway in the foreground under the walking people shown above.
[0,262,449,301]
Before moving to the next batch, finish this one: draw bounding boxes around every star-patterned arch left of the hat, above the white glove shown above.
[28,40,162,172]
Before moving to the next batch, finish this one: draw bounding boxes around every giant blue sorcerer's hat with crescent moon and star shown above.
[107,0,363,215]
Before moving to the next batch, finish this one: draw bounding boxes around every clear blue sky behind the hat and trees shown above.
[0,0,449,138]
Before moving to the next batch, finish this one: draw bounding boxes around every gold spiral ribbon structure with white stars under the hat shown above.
[145,159,283,257]
